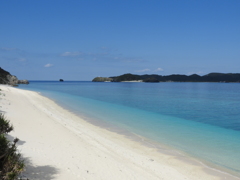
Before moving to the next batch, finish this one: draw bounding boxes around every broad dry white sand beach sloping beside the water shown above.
[0,85,237,180]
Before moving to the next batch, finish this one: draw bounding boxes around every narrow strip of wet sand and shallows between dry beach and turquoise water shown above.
[35,91,240,179]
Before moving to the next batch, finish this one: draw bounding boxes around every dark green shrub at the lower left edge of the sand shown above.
[0,113,24,180]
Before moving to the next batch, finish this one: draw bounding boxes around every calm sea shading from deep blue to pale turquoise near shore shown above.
[19,81,240,176]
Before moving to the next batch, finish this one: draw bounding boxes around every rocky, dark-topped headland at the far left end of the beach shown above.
[0,67,29,86]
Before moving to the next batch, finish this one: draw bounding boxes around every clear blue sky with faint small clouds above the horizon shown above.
[0,0,240,80]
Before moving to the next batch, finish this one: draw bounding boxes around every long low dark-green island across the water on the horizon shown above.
[92,73,240,83]
